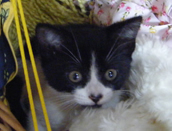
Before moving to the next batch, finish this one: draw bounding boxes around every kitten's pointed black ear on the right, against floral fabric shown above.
[106,16,142,58]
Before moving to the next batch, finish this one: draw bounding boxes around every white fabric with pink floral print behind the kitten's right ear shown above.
[93,0,172,47]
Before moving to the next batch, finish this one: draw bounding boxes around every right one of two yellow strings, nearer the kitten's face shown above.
[18,0,51,131]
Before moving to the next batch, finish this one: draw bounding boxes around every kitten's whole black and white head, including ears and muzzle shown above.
[36,17,142,106]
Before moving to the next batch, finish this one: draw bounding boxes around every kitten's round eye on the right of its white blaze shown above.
[105,69,117,81]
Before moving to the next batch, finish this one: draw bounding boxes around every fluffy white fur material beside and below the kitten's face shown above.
[70,35,172,131]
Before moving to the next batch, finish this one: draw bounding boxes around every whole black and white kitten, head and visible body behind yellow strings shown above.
[17,17,142,131]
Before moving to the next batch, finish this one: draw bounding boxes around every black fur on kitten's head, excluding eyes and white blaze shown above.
[35,17,142,92]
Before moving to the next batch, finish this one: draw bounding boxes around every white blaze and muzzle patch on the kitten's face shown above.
[74,54,119,106]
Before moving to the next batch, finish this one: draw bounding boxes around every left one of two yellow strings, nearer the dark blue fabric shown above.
[11,0,38,131]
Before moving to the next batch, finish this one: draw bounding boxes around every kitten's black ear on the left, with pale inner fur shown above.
[36,24,62,48]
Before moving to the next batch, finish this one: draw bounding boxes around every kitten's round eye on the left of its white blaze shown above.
[69,71,82,83]
